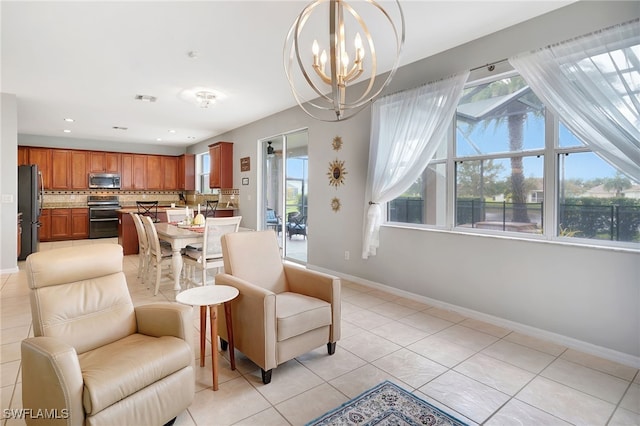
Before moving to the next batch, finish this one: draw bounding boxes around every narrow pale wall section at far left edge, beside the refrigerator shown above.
[0,93,18,273]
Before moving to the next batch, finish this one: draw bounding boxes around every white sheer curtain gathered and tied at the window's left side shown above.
[362,72,469,259]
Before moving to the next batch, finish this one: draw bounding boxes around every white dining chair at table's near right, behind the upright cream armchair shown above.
[182,216,242,285]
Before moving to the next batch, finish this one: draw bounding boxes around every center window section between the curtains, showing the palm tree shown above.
[454,75,545,233]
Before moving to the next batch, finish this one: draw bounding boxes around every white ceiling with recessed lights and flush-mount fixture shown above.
[0,0,573,146]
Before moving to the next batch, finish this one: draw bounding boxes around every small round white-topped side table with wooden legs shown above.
[176,285,239,391]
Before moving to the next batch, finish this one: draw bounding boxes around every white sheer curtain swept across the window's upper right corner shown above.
[509,19,640,182]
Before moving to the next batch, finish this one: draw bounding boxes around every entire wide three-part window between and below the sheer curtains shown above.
[387,71,640,248]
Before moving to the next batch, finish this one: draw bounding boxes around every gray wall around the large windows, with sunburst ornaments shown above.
[189,1,640,366]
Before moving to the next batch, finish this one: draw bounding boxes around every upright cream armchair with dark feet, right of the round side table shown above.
[216,230,341,384]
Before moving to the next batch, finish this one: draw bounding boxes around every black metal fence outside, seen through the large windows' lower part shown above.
[388,198,640,242]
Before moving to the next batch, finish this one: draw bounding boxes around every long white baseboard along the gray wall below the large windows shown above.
[307,265,640,368]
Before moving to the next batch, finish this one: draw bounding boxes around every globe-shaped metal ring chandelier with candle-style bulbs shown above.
[284,0,404,121]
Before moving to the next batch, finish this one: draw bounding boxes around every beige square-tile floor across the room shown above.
[0,240,640,426]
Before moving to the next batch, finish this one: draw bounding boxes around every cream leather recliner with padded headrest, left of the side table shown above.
[22,244,195,425]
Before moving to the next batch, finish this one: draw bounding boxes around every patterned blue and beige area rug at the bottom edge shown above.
[306,381,467,426]
